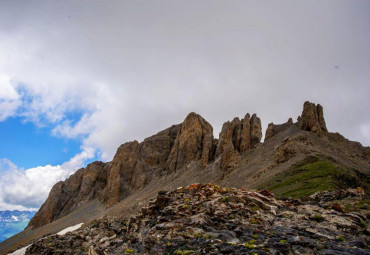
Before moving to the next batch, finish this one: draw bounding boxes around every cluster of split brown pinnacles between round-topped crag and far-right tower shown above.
[216,113,262,169]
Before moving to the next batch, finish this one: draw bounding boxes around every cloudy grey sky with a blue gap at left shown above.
[0,0,370,210]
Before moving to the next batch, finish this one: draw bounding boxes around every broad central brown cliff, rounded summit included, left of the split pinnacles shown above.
[102,113,217,205]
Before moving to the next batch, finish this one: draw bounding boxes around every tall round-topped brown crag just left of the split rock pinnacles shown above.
[166,112,214,172]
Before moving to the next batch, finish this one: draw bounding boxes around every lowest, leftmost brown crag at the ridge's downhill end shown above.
[27,161,110,229]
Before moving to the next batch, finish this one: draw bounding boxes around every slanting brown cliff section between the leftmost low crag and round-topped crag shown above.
[101,125,180,205]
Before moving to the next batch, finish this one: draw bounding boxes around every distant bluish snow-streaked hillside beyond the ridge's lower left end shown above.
[0,211,36,242]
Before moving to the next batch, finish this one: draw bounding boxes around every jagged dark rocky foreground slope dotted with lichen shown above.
[26,184,370,255]
